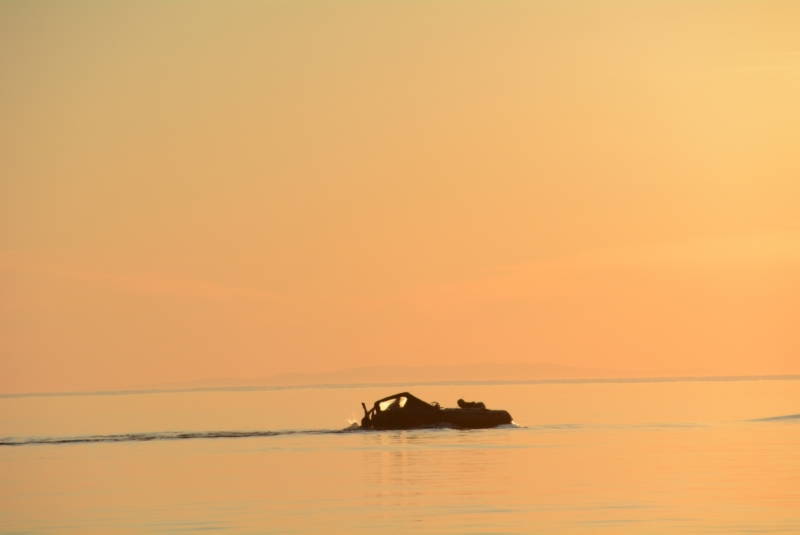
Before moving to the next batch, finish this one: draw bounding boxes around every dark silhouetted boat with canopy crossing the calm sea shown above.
[361,392,511,429]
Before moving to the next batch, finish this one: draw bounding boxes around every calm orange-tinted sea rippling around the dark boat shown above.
[0,376,800,534]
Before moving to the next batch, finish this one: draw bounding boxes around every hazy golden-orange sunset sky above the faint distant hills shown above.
[0,0,800,393]
